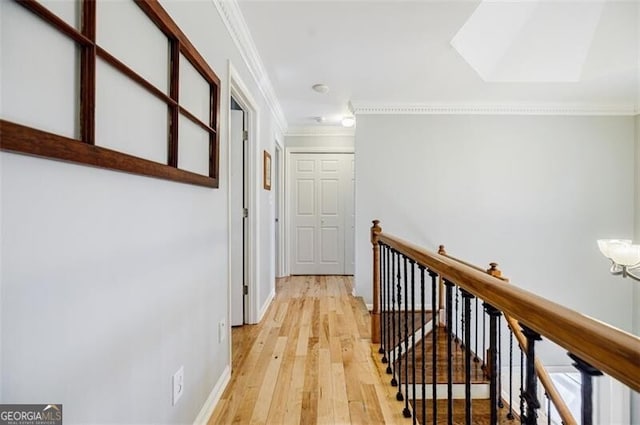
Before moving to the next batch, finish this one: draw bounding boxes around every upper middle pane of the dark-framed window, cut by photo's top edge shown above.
[96,0,169,93]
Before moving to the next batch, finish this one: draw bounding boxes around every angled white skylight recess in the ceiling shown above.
[451,0,605,82]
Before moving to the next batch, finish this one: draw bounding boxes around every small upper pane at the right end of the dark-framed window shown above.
[179,55,211,125]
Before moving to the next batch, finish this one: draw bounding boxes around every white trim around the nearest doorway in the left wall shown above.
[226,61,261,328]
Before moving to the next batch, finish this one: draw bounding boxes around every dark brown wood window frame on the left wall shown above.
[0,0,220,188]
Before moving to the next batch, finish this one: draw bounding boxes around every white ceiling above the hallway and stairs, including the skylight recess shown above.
[238,0,640,127]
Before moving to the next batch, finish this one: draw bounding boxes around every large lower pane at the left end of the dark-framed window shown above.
[0,0,79,138]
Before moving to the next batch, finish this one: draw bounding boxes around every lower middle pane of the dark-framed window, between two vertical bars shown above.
[96,60,167,164]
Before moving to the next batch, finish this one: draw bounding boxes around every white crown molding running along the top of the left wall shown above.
[211,0,288,133]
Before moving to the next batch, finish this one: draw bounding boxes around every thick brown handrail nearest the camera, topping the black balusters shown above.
[372,223,640,391]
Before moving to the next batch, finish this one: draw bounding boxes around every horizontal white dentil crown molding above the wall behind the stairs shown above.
[350,102,639,116]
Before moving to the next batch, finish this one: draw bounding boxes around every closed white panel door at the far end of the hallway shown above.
[289,153,353,274]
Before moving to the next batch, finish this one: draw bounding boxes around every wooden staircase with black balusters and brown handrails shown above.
[371,221,640,425]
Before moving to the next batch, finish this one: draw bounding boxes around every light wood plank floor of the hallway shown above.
[209,276,410,425]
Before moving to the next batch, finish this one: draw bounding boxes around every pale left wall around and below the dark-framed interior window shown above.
[0,1,279,424]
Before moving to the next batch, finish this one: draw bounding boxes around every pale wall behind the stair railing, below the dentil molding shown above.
[356,115,634,338]
